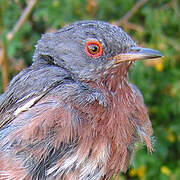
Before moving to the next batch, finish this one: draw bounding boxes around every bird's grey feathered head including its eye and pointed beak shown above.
[34,21,162,81]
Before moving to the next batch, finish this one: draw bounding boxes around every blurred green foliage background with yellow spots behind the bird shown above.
[0,0,180,180]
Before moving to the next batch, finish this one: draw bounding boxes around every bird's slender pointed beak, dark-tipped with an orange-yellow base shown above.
[109,47,163,63]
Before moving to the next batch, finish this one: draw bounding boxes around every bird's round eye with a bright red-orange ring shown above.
[85,41,103,58]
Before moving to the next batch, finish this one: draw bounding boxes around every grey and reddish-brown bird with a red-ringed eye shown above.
[0,20,163,180]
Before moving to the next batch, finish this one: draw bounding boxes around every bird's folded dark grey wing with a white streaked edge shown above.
[0,64,71,129]
